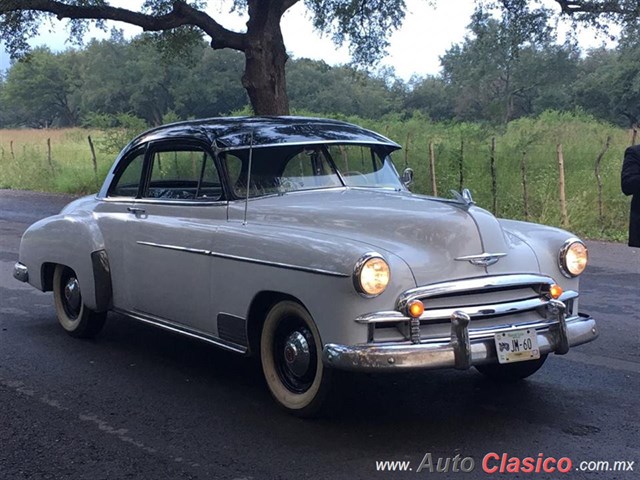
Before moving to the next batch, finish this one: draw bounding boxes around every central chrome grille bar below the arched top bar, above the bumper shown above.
[355,290,578,324]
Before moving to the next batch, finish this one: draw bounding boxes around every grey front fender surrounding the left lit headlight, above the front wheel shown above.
[213,222,416,344]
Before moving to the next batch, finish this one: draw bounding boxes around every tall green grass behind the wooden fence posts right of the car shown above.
[336,110,629,241]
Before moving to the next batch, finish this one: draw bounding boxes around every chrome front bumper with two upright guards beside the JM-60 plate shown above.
[323,300,598,372]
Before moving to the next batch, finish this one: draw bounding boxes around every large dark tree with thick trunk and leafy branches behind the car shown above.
[0,0,405,114]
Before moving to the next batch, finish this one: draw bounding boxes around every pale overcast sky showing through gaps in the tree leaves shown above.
[0,0,620,80]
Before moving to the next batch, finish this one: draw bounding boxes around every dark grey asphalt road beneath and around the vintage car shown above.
[0,191,640,480]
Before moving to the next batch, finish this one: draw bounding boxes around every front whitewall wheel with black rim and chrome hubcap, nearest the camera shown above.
[260,300,331,417]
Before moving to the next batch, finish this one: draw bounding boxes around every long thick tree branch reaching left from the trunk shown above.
[0,0,245,51]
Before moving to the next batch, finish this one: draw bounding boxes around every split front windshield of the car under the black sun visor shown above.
[222,144,404,198]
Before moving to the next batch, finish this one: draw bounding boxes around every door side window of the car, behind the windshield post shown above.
[143,147,222,201]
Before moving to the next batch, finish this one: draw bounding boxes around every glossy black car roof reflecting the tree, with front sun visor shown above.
[130,117,400,151]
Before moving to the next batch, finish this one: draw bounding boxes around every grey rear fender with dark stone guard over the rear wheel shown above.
[19,210,111,311]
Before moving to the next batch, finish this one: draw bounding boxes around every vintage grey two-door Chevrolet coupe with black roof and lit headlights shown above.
[14,117,597,416]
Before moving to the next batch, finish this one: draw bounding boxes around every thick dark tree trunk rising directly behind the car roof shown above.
[242,0,289,115]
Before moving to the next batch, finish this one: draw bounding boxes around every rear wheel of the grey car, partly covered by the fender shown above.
[53,265,107,338]
